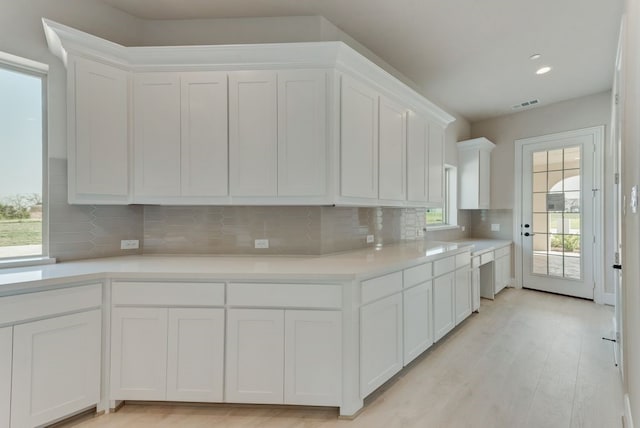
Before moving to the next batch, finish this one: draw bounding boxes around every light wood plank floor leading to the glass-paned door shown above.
[58,289,622,428]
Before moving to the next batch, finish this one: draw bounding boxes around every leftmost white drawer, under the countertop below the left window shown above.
[0,284,102,325]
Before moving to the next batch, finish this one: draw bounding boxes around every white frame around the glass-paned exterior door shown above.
[513,125,605,304]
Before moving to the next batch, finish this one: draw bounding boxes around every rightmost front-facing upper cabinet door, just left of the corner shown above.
[278,70,327,196]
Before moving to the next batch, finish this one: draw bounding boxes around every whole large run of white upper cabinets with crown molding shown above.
[43,19,455,206]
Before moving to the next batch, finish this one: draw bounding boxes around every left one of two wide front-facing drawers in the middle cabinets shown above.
[111,281,224,306]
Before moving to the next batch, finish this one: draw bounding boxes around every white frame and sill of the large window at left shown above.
[0,51,56,269]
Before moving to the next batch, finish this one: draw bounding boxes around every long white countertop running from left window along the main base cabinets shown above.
[0,241,472,296]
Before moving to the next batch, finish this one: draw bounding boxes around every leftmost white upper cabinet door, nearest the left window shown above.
[69,58,129,203]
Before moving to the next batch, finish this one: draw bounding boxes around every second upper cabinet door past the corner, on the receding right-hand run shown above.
[378,97,407,201]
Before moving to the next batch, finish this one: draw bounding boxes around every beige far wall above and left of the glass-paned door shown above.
[471,91,611,209]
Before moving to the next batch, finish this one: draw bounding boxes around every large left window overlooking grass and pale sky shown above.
[0,52,46,262]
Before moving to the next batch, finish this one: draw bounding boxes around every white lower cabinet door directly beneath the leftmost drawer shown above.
[11,309,102,427]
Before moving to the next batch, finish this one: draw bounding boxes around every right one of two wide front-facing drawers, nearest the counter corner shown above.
[227,283,342,309]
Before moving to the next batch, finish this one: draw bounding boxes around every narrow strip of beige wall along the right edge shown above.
[621,0,640,427]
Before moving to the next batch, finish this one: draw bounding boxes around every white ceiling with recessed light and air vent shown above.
[97,0,623,122]
